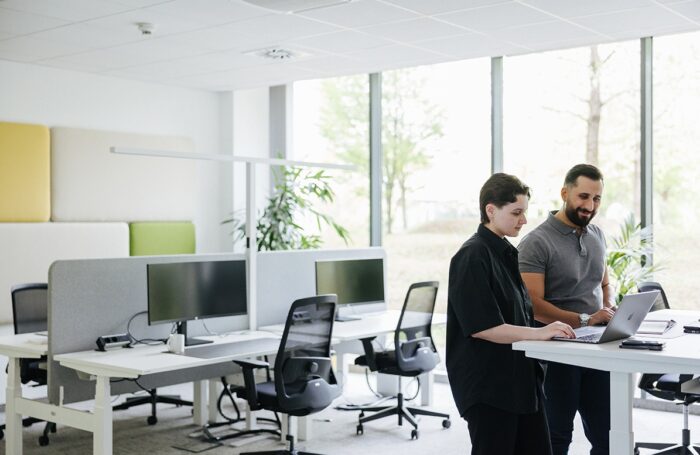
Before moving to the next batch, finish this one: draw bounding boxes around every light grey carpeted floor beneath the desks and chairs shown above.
[0,374,700,455]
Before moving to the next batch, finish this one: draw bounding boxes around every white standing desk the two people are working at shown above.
[513,310,700,455]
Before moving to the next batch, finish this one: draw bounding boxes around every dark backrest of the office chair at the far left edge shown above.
[11,283,48,334]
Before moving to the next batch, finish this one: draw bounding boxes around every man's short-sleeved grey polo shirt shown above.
[518,212,605,314]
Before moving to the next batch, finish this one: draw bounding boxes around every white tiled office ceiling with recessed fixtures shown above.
[0,0,700,91]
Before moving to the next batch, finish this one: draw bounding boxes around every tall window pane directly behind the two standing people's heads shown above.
[503,41,640,243]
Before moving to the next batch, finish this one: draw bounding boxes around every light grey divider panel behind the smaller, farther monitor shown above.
[257,247,388,327]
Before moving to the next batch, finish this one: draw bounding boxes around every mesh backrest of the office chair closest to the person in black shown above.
[394,281,440,373]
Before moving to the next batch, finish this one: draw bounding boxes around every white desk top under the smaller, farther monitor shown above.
[259,310,447,343]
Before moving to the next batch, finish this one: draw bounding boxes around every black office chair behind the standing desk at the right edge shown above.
[634,281,700,455]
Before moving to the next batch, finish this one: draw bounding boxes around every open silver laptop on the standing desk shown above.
[552,291,661,344]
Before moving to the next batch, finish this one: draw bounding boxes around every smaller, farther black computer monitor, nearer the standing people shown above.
[316,258,384,320]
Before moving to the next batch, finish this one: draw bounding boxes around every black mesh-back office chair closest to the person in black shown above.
[355,281,451,439]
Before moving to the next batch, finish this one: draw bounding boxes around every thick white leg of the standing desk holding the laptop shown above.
[610,371,634,455]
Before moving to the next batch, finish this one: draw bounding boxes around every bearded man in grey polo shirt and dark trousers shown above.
[518,164,614,455]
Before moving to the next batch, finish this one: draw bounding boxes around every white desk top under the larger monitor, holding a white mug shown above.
[54,331,277,378]
